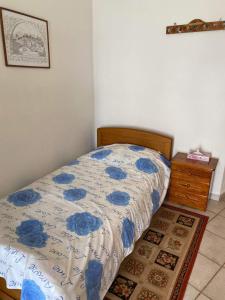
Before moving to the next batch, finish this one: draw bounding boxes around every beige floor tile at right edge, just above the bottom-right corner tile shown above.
[199,230,225,266]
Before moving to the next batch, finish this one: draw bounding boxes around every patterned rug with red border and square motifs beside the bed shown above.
[104,205,208,300]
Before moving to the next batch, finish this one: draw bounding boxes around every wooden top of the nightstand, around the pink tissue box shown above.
[172,152,218,172]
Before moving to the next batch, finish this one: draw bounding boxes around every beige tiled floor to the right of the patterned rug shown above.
[173,200,225,300]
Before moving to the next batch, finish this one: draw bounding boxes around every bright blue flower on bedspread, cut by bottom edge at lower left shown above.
[21,279,46,300]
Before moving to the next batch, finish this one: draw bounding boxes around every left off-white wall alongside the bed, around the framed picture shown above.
[0,0,94,196]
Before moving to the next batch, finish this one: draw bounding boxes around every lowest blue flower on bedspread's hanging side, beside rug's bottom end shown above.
[85,260,103,300]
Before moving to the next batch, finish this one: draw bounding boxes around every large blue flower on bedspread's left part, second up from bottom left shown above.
[16,220,48,248]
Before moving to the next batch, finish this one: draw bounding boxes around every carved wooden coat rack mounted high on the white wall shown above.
[166,19,225,34]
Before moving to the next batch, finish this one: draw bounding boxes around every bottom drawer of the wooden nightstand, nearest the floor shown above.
[169,187,208,210]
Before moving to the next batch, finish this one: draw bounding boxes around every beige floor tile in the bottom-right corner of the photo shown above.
[203,268,225,300]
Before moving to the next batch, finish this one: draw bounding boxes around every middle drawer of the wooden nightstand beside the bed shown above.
[171,176,209,196]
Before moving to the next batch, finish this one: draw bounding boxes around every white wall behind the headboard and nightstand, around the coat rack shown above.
[93,0,225,194]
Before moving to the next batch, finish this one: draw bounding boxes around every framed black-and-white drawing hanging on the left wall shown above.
[0,7,50,68]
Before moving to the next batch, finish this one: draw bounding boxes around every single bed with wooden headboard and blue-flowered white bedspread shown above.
[0,128,173,300]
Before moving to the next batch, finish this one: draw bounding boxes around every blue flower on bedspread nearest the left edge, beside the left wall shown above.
[8,189,41,206]
